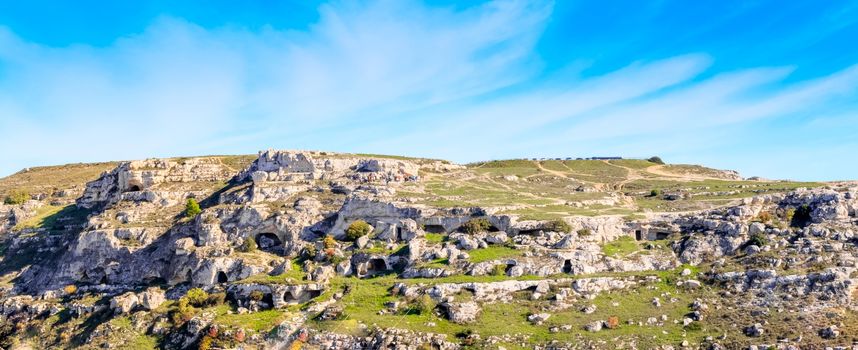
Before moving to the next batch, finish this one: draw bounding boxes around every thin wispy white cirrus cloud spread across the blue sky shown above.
[0,1,858,179]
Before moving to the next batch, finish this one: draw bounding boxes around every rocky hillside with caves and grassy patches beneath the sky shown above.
[0,150,858,349]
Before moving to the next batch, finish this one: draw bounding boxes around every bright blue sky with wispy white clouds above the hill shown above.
[0,0,858,180]
